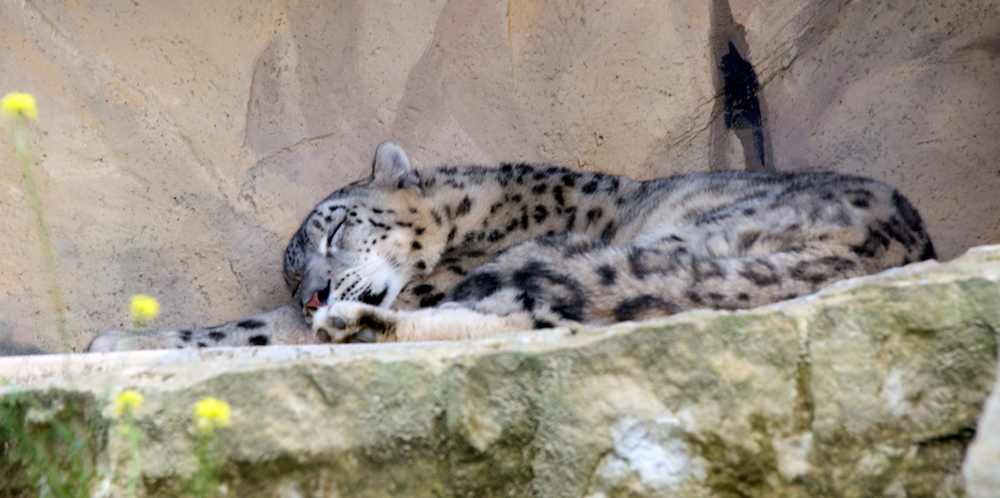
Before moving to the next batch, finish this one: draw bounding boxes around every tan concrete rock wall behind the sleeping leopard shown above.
[0,0,1000,352]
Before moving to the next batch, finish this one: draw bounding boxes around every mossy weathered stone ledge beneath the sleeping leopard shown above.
[0,247,1000,497]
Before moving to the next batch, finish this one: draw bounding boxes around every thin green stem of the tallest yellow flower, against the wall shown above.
[13,116,70,353]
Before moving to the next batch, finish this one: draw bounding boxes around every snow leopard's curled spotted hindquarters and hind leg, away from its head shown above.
[438,169,934,328]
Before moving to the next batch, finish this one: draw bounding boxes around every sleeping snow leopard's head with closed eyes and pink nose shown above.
[284,142,444,317]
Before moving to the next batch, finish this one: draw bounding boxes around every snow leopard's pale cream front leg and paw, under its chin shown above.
[313,301,533,342]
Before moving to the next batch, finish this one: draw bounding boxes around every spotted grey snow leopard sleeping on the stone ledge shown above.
[90,142,935,351]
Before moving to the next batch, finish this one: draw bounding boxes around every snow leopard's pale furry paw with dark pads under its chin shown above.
[312,301,396,342]
